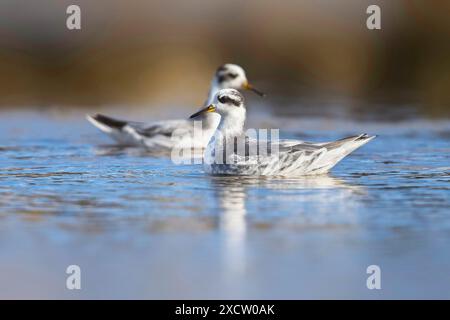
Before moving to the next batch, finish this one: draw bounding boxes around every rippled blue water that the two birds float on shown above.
[0,111,450,299]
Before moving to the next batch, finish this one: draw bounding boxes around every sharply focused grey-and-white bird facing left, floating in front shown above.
[191,89,375,176]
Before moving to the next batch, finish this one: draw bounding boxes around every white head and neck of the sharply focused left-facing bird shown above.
[191,89,246,135]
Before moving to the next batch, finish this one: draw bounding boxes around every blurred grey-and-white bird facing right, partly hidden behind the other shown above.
[86,64,264,151]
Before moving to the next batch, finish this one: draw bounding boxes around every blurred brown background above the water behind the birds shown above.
[0,0,450,117]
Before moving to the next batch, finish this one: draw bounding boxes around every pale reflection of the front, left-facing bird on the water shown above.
[210,175,364,285]
